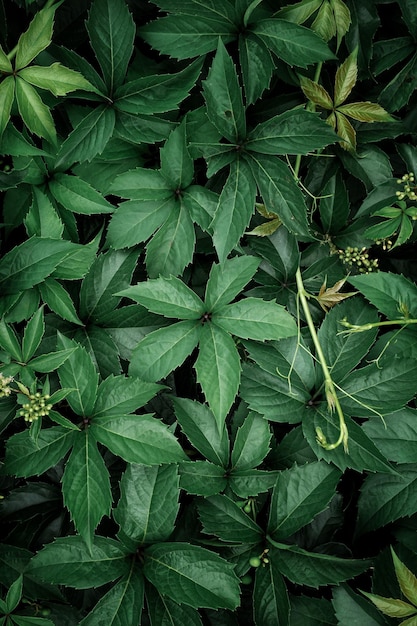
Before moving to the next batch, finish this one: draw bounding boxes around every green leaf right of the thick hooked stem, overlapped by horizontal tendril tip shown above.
[318,298,378,382]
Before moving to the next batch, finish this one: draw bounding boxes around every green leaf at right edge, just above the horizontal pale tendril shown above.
[348,272,417,320]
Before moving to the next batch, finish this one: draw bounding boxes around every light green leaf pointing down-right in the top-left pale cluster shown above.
[16,76,56,145]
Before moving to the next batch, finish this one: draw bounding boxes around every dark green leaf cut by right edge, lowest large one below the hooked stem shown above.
[357,463,417,534]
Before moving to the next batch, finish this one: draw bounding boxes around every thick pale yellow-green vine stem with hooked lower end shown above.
[295,268,348,453]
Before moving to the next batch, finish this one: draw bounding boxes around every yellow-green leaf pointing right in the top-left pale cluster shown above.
[18,63,95,96]
